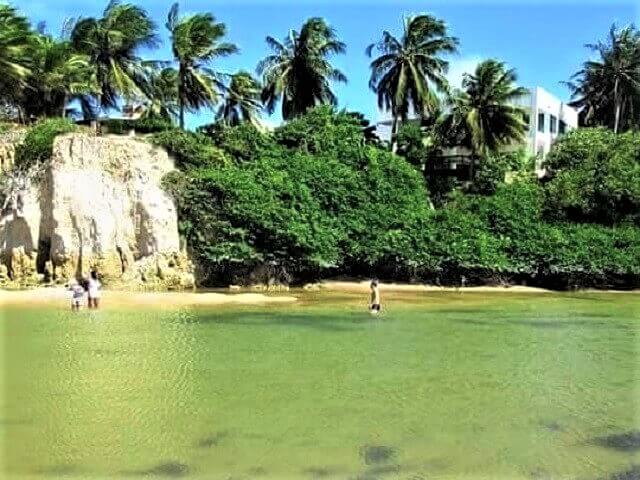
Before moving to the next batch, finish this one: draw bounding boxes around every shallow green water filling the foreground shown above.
[0,293,640,480]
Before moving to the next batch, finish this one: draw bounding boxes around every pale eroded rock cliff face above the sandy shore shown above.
[0,134,194,289]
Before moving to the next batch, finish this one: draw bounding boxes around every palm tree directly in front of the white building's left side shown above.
[443,60,528,179]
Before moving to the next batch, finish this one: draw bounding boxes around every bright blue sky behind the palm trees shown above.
[12,0,639,127]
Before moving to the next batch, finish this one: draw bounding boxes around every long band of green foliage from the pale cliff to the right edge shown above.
[165,108,640,288]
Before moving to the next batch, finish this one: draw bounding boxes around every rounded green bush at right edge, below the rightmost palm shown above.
[546,129,640,225]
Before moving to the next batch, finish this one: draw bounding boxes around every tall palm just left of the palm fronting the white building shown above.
[367,15,458,152]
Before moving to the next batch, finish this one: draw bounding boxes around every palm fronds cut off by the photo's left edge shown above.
[0,4,33,120]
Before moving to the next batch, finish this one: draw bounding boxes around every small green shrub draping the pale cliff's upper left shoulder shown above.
[15,118,78,168]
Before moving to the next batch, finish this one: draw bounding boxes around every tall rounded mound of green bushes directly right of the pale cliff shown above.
[165,109,428,281]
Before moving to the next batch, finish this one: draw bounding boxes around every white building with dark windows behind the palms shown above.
[376,87,578,169]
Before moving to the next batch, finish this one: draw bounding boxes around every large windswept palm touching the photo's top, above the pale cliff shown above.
[70,0,158,114]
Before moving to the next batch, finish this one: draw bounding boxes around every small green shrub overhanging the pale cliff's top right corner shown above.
[151,129,228,170]
